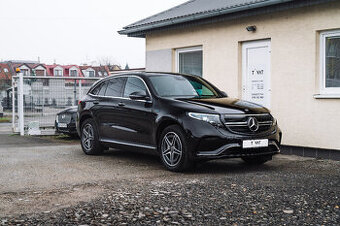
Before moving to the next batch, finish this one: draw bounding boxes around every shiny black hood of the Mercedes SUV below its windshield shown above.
[177,97,269,114]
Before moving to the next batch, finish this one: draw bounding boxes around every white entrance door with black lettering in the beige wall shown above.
[242,40,271,108]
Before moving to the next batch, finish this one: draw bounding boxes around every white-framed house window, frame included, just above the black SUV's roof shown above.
[175,46,203,76]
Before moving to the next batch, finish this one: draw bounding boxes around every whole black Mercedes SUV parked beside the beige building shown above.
[77,72,282,171]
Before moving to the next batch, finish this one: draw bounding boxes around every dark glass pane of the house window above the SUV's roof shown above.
[179,51,203,76]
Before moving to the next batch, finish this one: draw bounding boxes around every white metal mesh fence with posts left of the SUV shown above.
[7,73,100,135]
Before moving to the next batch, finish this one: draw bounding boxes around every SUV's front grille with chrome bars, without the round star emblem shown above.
[224,113,273,134]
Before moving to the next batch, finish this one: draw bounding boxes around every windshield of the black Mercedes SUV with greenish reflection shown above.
[149,75,220,98]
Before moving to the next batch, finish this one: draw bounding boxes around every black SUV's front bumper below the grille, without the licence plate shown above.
[182,115,282,159]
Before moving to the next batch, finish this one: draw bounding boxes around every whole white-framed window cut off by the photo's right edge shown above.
[320,30,340,94]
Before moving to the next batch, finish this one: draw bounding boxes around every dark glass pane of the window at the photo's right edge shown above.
[326,36,340,88]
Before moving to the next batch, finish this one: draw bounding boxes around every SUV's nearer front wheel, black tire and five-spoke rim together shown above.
[158,125,194,172]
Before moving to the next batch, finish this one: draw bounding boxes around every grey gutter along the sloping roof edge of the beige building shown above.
[118,0,293,35]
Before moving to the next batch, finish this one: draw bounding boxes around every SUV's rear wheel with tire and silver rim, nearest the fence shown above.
[80,118,104,155]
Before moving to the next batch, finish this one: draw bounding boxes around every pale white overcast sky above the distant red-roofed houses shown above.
[0,0,186,67]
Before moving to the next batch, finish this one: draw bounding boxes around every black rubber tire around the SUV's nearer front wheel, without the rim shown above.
[158,125,193,172]
